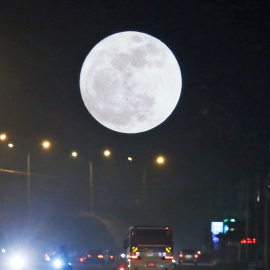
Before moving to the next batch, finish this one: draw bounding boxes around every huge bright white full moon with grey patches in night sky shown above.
[80,31,182,133]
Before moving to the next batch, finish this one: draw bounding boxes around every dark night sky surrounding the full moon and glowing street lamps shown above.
[0,0,270,253]
